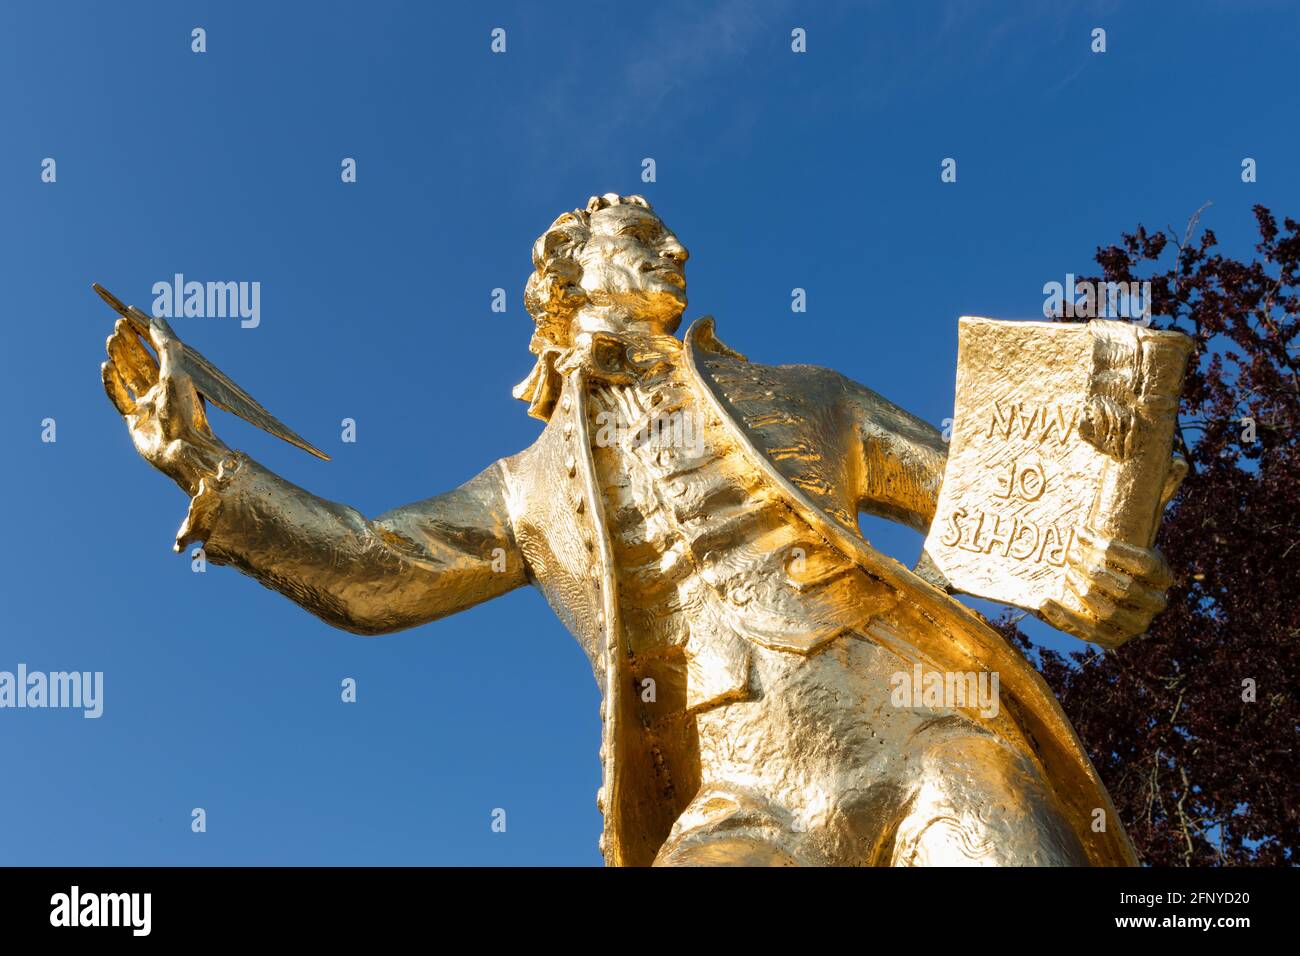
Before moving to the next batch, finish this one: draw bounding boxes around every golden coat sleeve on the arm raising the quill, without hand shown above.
[176,453,528,635]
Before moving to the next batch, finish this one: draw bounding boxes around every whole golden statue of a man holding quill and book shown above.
[103,194,1187,866]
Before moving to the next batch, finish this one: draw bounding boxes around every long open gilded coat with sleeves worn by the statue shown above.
[177,319,1136,865]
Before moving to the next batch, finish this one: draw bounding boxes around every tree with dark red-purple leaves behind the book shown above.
[998,206,1300,866]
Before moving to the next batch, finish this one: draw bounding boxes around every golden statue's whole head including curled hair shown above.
[524,193,689,352]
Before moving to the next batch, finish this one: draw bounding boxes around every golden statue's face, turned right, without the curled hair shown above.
[579,204,689,330]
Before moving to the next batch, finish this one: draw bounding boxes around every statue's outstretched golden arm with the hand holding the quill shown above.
[103,310,528,635]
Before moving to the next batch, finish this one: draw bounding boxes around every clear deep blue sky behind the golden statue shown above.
[0,0,1300,865]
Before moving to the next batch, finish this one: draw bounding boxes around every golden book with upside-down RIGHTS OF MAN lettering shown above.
[926,316,1193,610]
